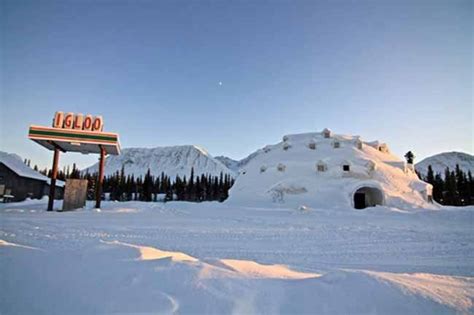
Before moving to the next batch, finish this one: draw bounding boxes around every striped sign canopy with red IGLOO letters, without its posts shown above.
[28,112,120,155]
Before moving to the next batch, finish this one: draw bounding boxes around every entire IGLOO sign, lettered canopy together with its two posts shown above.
[28,112,120,211]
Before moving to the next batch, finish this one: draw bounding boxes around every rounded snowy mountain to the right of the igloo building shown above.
[415,152,474,175]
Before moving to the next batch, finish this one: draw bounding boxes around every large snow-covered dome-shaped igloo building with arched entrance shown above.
[227,129,435,209]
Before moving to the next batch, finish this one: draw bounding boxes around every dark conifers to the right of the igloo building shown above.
[417,164,474,206]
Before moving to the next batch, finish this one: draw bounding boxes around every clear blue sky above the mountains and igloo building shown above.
[0,0,474,168]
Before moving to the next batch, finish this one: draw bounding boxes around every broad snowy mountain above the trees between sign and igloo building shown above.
[84,145,234,179]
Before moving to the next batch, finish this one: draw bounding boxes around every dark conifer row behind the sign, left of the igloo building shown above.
[36,164,234,202]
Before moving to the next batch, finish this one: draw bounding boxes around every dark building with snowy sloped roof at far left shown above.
[0,152,64,201]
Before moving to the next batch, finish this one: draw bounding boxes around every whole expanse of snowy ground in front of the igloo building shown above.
[0,201,474,314]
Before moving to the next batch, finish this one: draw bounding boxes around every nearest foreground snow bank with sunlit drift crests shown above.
[0,242,474,314]
